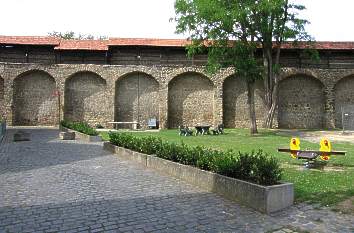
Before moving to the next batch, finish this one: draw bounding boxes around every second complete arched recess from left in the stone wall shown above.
[64,71,106,125]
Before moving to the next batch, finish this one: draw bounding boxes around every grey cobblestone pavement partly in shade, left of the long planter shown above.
[0,128,354,233]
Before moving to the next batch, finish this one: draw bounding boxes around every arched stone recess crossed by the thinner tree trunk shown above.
[223,75,266,128]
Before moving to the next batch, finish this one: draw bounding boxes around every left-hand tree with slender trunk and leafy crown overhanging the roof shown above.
[175,0,261,134]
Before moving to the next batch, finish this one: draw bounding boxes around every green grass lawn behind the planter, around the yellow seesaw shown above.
[102,129,354,205]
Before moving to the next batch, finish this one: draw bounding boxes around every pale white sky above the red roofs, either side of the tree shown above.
[0,0,354,41]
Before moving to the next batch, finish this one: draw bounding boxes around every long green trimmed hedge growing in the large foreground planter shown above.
[109,132,282,185]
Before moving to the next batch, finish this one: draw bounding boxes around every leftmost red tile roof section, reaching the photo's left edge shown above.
[0,36,60,45]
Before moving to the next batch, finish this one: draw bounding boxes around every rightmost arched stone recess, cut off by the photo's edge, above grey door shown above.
[334,74,354,128]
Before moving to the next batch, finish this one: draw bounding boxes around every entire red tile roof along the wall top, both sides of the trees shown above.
[0,36,354,51]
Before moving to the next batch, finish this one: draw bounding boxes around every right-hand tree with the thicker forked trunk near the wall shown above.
[252,0,317,128]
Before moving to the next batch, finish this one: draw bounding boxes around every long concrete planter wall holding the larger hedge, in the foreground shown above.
[103,142,294,214]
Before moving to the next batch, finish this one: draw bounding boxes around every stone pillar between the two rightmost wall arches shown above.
[323,84,335,129]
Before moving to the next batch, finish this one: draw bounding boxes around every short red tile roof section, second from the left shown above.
[54,40,108,51]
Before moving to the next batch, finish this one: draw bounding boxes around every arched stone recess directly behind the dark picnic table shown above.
[168,72,214,128]
